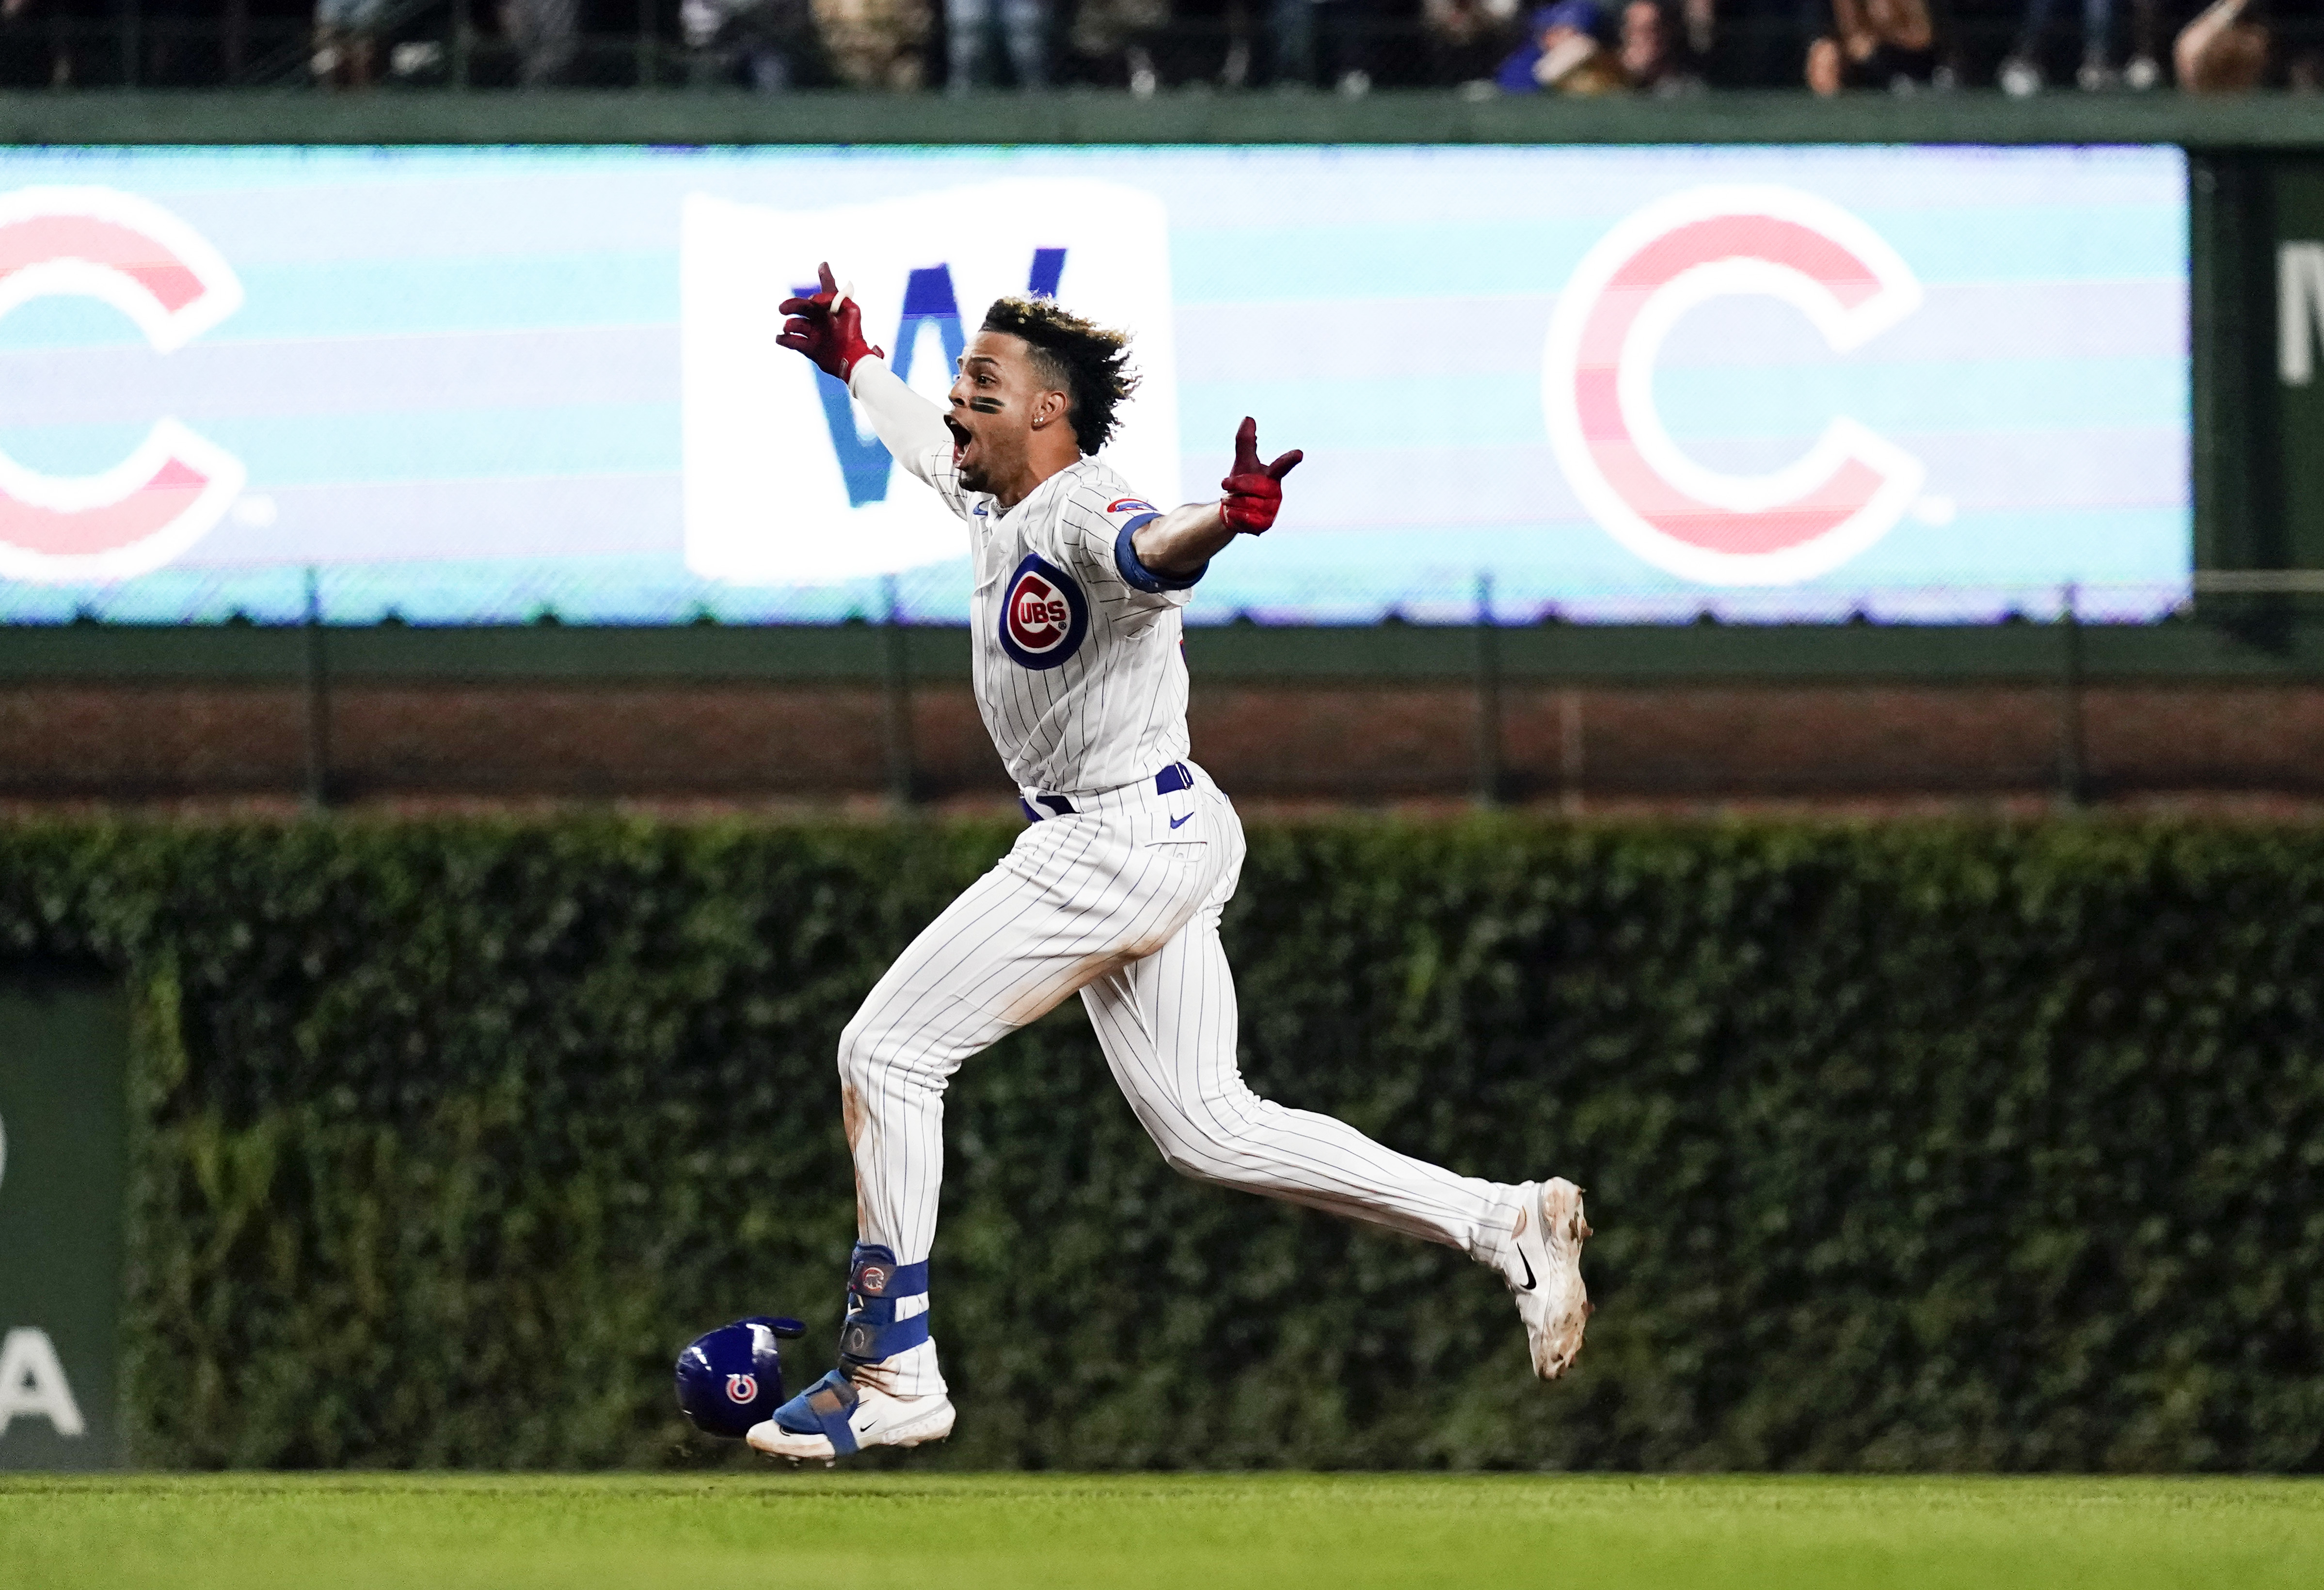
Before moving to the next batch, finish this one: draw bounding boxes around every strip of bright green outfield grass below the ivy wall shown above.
[0,1469,2324,1590]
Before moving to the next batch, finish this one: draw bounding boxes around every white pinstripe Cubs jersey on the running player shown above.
[904,446,1199,795]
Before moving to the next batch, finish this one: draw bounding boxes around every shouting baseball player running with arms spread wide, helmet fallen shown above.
[748,265,1590,1458]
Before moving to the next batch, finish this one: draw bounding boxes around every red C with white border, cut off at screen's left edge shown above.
[0,188,244,581]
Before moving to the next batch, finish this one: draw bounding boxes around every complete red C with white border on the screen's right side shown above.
[1541,186,1926,586]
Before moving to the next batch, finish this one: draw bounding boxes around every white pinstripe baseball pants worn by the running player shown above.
[839,769,1517,1395]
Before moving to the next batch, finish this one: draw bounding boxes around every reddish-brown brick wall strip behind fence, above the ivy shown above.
[14,681,2324,809]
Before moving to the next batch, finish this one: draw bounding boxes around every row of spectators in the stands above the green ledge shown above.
[0,0,2324,97]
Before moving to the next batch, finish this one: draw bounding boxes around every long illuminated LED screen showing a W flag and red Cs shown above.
[0,146,2192,623]
